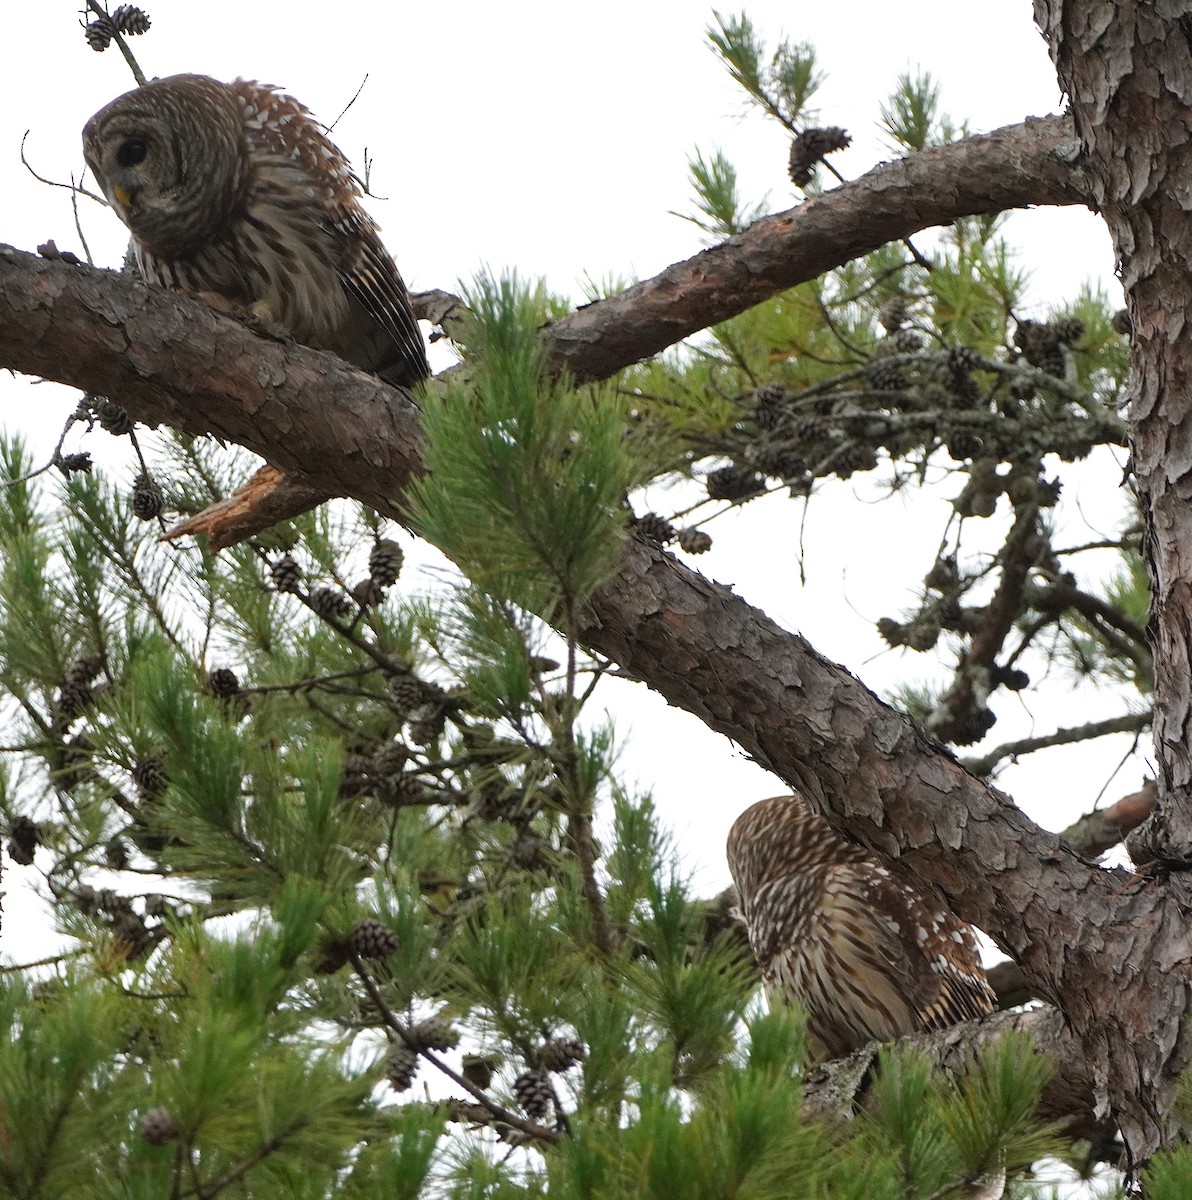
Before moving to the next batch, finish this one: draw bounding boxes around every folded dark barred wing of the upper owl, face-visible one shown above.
[336,206,430,386]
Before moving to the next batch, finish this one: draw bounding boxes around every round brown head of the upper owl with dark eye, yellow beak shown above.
[83,74,244,259]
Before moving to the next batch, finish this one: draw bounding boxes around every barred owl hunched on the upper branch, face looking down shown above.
[83,74,429,385]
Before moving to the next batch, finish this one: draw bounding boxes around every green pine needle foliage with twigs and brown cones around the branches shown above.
[0,6,1190,1200]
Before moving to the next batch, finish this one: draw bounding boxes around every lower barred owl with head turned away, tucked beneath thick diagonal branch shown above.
[729,796,994,1060]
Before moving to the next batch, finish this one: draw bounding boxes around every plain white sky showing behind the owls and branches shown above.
[0,0,1142,936]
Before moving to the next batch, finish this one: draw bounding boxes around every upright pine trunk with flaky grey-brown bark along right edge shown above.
[1035,0,1192,1153]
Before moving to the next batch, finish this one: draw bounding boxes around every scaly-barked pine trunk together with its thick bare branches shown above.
[0,18,1192,1159]
